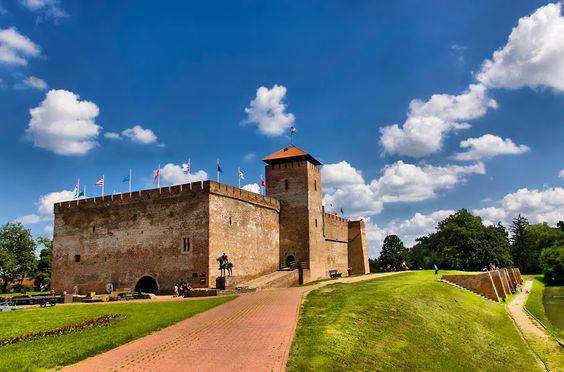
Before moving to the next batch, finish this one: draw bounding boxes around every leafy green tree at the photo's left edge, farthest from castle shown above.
[0,222,37,292]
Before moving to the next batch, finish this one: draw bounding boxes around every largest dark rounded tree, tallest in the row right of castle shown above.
[409,209,512,270]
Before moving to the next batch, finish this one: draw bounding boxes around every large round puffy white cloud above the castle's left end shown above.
[26,90,100,155]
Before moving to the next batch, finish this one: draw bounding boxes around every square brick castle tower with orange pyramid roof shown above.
[262,146,323,268]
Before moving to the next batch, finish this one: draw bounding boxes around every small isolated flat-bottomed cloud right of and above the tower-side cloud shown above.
[455,134,530,160]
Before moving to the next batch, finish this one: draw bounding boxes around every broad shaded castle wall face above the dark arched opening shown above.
[52,182,209,293]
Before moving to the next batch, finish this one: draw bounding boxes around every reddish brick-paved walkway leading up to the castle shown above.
[66,273,396,372]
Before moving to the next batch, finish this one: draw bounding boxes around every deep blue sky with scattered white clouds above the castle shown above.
[0,0,564,255]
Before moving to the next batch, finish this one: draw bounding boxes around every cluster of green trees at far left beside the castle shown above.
[0,222,53,293]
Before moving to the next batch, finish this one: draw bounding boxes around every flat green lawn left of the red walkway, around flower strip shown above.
[0,296,235,371]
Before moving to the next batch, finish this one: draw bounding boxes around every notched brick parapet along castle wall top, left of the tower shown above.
[55,180,280,213]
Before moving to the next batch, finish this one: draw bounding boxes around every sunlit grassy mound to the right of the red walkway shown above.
[288,271,537,371]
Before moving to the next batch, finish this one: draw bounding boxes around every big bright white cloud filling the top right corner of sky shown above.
[477,2,564,91]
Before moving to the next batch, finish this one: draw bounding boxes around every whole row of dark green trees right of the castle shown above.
[370,209,564,285]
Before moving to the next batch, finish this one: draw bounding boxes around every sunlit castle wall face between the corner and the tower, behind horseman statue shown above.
[209,185,280,285]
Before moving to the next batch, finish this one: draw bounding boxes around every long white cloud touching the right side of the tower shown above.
[321,160,485,218]
